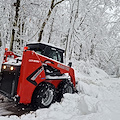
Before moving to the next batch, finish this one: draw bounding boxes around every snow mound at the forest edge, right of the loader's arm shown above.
[73,60,109,80]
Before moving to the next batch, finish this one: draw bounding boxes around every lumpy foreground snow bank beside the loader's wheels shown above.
[0,94,103,120]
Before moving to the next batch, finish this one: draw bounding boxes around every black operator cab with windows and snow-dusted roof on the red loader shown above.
[27,43,64,63]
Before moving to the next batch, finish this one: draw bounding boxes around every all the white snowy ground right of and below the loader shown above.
[0,62,120,120]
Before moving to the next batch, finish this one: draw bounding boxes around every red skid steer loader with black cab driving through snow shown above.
[0,43,75,108]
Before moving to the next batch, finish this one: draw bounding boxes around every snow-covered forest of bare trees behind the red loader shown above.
[0,0,120,77]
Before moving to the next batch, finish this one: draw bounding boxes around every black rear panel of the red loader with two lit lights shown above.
[0,64,20,98]
